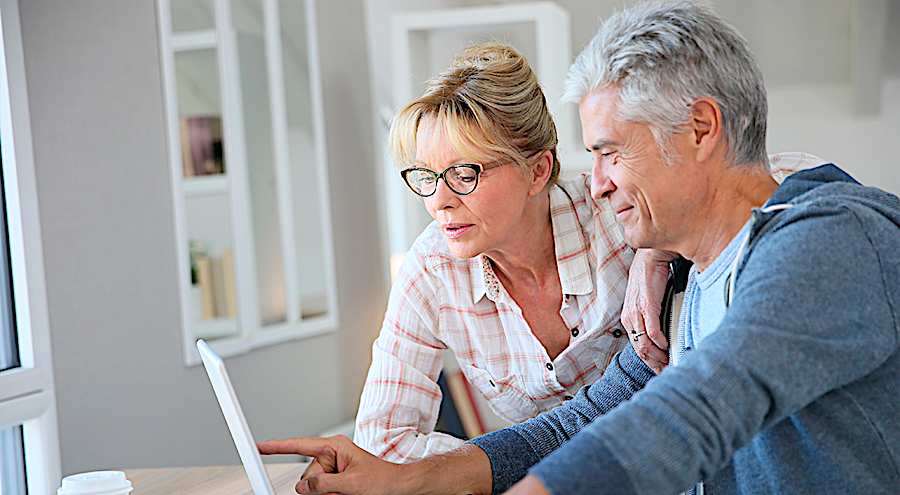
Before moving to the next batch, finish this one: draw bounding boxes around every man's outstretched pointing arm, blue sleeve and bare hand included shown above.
[259,346,654,495]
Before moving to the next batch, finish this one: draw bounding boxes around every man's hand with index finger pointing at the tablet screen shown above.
[256,436,403,495]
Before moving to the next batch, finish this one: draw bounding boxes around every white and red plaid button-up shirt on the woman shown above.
[354,174,632,462]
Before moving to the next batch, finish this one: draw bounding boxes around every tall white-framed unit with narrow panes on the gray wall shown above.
[157,0,338,366]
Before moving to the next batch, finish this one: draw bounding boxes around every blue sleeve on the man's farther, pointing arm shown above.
[470,346,654,493]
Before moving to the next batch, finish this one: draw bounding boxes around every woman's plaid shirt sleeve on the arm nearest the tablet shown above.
[354,253,463,462]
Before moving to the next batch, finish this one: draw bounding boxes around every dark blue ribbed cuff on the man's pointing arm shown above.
[468,428,541,494]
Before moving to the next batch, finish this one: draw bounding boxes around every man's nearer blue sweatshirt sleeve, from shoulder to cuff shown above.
[531,202,900,494]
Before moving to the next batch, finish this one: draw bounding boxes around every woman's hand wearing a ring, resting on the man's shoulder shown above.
[622,249,675,374]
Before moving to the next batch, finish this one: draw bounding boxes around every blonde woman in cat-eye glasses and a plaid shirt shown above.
[354,43,652,462]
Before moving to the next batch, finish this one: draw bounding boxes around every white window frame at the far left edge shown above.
[0,0,61,493]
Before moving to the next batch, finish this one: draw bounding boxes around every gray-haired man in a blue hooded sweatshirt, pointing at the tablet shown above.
[260,2,900,494]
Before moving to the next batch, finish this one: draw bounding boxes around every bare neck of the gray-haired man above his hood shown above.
[677,165,778,271]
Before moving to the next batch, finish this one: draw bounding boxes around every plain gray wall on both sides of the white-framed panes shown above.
[20,0,387,473]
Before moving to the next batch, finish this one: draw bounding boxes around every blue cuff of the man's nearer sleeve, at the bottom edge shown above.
[528,431,637,495]
